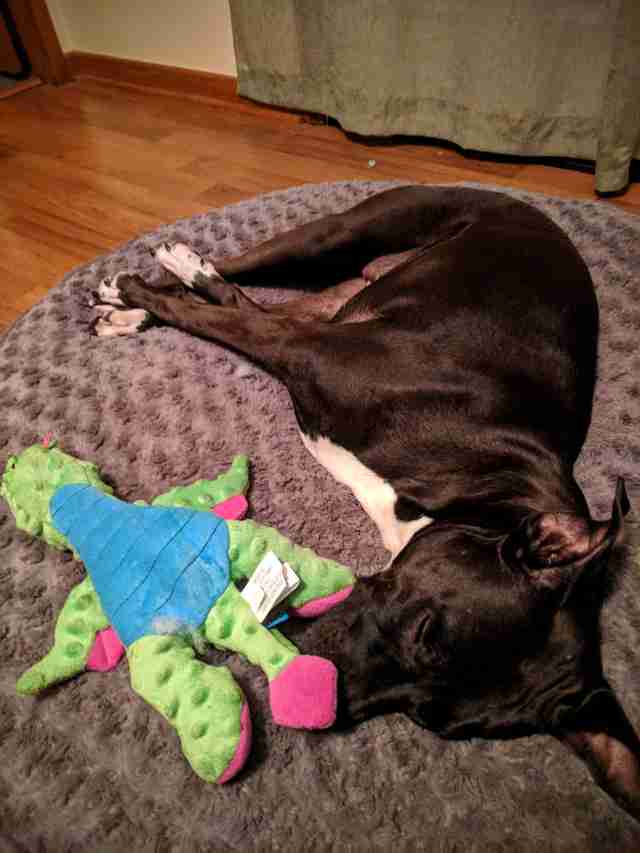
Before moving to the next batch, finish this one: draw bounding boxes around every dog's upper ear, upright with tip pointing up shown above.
[502,479,630,601]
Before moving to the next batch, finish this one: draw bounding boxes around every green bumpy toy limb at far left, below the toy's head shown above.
[16,578,109,696]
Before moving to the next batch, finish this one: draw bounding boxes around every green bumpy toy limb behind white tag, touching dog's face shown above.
[227,521,355,607]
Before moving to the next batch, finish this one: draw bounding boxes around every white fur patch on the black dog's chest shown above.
[300,433,433,556]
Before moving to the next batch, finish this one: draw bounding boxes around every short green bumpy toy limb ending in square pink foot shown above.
[205,583,300,681]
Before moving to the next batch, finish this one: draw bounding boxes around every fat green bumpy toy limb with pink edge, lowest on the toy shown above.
[127,635,245,782]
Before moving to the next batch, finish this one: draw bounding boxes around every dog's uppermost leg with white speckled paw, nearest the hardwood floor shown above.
[150,186,464,319]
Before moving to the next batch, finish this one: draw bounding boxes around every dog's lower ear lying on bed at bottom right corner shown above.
[551,680,640,821]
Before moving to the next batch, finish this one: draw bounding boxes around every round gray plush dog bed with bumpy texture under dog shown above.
[0,183,640,853]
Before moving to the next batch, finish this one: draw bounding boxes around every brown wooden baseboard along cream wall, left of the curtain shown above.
[66,50,240,101]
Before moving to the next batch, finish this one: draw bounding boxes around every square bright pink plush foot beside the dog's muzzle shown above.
[269,655,338,729]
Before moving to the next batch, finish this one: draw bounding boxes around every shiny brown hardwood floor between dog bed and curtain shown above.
[0,78,640,330]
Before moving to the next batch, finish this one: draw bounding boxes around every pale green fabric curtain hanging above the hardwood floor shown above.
[230,0,640,192]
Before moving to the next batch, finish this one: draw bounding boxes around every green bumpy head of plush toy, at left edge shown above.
[0,443,113,550]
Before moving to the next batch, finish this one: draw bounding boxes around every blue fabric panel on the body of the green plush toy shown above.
[49,484,229,646]
